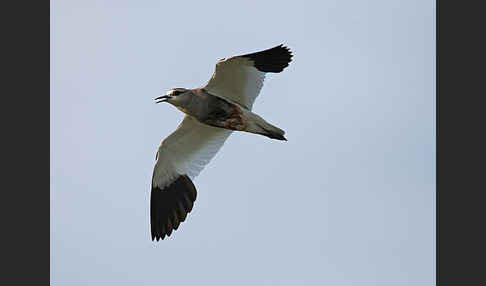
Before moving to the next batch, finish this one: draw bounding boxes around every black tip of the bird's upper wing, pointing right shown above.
[241,44,293,73]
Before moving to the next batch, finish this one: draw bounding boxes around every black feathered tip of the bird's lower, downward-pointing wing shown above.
[150,175,197,241]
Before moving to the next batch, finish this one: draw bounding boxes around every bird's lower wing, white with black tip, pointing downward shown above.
[150,115,232,241]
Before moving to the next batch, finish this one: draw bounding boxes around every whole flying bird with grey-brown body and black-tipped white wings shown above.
[150,45,292,241]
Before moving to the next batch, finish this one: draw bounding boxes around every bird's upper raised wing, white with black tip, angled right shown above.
[202,45,292,110]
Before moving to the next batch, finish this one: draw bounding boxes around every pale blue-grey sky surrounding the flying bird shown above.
[50,0,436,286]
